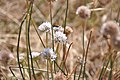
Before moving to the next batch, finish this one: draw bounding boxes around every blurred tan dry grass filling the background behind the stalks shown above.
[0,0,120,80]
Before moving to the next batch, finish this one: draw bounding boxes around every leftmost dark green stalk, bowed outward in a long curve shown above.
[17,14,27,80]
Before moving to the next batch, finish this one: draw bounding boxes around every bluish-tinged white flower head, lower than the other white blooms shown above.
[40,48,57,61]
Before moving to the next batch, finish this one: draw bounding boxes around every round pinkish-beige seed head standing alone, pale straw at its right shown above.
[76,6,91,19]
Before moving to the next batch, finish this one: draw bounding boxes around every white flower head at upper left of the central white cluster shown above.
[38,22,51,32]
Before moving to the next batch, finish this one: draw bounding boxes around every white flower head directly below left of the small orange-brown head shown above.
[54,31,67,43]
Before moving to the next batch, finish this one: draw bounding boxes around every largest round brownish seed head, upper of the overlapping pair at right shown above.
[101,21,120,37]
